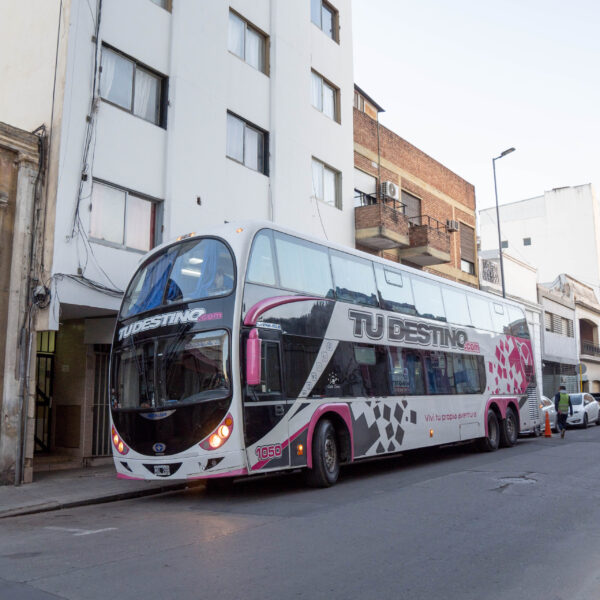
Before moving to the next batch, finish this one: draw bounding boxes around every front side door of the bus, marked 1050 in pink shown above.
[244,329,293,472]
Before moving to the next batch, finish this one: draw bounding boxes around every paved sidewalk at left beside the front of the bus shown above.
[0,465,199,519]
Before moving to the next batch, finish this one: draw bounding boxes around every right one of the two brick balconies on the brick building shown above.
[398,215,450,267]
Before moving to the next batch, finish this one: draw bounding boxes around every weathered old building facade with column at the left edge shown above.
[0,123,48,484]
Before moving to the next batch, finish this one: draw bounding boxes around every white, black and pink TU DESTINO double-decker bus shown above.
[110,222,540,486]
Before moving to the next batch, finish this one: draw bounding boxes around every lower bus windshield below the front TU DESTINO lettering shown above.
[111,329,231,410]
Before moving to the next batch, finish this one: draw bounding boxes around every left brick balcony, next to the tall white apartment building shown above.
[354,194,410,250]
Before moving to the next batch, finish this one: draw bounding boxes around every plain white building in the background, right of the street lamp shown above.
[479,184,600,287]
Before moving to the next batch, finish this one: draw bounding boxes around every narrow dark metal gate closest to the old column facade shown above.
[33,331,56,453]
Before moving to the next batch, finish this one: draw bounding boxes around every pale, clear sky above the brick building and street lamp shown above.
[352,0,600,210]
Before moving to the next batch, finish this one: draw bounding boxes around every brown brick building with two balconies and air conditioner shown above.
[354,85,478,287]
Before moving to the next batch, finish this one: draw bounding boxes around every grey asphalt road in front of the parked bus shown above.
[0,427,600,600]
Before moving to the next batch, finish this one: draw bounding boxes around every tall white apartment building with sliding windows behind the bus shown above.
[0,0,354,480]
